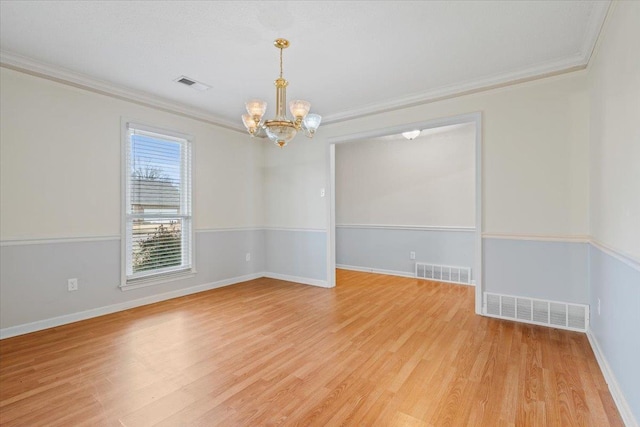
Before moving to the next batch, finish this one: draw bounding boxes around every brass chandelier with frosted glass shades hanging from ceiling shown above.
[242,39,322,148]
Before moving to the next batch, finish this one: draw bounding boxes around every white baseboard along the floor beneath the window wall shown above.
[0,273,264,339]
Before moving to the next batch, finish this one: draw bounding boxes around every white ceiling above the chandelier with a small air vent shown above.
[0,0,610,129]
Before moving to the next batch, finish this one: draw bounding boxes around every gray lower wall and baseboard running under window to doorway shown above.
[0,229,327,336]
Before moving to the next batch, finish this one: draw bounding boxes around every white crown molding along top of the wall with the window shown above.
[0,51,244,133]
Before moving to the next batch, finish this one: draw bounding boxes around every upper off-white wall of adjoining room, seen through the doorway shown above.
[335,123,475,227]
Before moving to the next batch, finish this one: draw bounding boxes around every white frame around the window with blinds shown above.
[119,118,196,291]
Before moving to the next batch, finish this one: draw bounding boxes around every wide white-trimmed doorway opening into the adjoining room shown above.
[327,113,482,314]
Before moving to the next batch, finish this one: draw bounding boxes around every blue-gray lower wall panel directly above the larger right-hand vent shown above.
[482,238,589,304]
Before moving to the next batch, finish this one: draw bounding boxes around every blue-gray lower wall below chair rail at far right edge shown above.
[589,246,640,425]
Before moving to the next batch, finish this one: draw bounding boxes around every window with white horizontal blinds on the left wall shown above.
[122,123,193,287]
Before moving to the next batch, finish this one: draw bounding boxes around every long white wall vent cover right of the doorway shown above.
[484,292,589,332]
